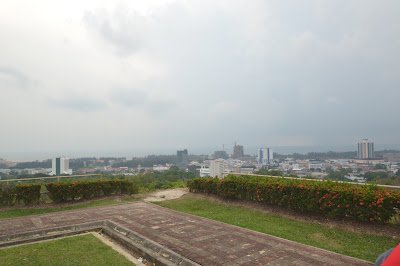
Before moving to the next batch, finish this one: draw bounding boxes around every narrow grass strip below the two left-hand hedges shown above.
[0,196,137,219]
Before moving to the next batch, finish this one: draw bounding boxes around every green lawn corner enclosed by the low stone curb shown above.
[0,234,133,266]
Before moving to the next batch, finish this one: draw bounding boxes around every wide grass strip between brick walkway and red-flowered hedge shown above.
[156,195,398,262]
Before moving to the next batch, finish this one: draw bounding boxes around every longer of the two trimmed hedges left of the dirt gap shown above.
[46,179,138,203]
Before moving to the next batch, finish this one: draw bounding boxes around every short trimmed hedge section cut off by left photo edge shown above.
[0,184,41,206]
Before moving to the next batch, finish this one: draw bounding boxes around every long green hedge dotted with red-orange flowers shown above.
[188,176,400,222]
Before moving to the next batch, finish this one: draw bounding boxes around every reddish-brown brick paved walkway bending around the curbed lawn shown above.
[0,202,368,265]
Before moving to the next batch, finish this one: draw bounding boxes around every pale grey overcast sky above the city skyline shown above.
[0,0,400,156]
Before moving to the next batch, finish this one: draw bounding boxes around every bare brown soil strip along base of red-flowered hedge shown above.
[183,193,400,240]
